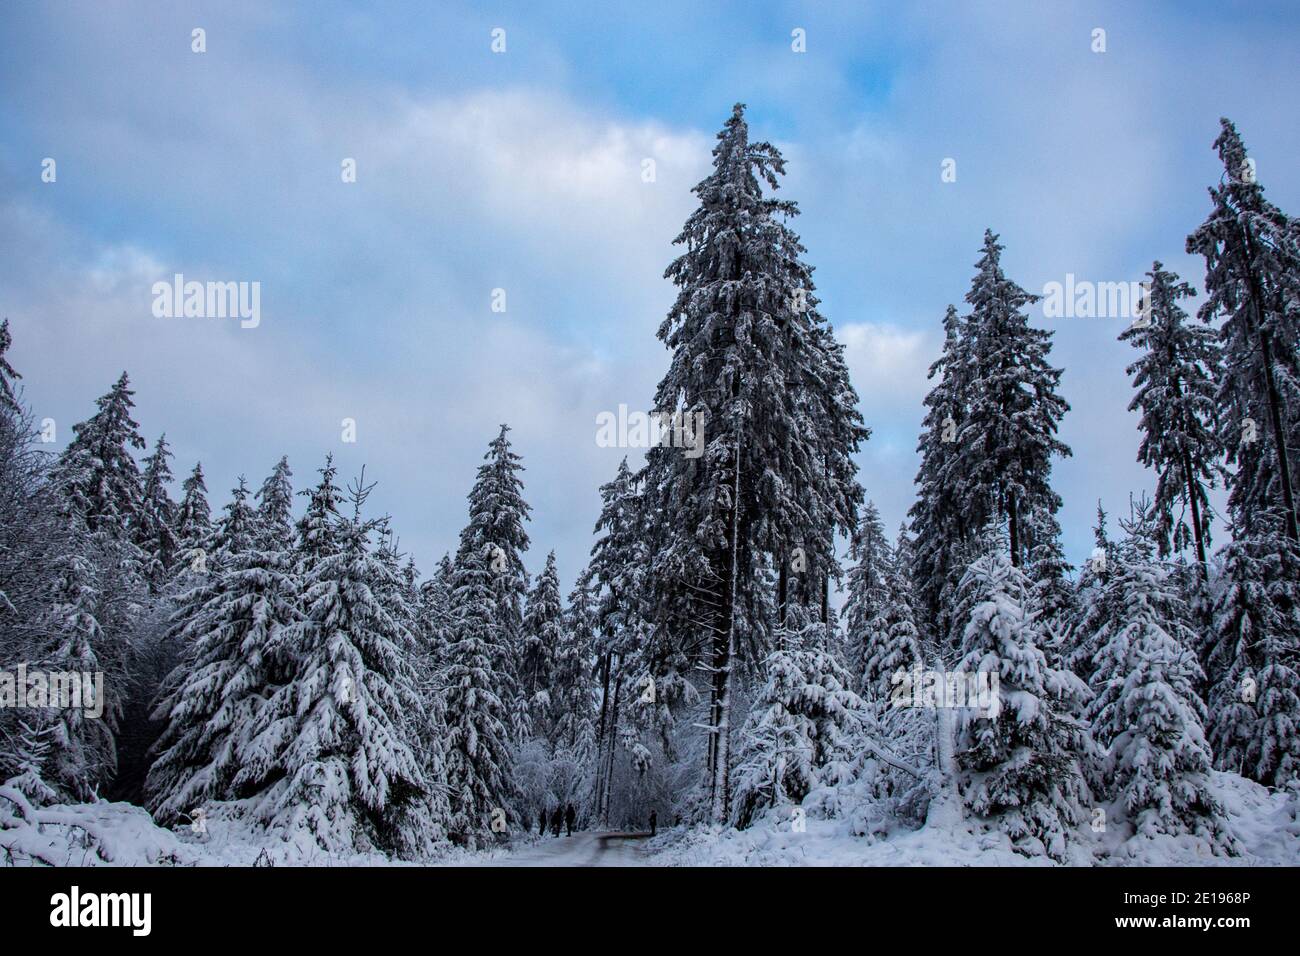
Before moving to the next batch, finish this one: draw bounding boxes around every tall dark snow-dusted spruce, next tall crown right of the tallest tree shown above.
[946,230,1070,567]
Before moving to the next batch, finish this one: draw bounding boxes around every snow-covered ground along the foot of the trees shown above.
[0,773,1300,866]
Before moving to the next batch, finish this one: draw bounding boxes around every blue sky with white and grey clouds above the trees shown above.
[0,0,1300,585]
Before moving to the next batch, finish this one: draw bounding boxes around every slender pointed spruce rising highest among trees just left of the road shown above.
[459,425,532,743]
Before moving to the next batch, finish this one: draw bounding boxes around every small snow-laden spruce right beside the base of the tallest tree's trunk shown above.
[733,632,866,827]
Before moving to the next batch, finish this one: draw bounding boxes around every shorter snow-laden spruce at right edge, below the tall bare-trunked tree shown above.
[1206,524,1300,787]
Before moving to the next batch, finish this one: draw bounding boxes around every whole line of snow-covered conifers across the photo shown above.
[0,105,1300,858]
